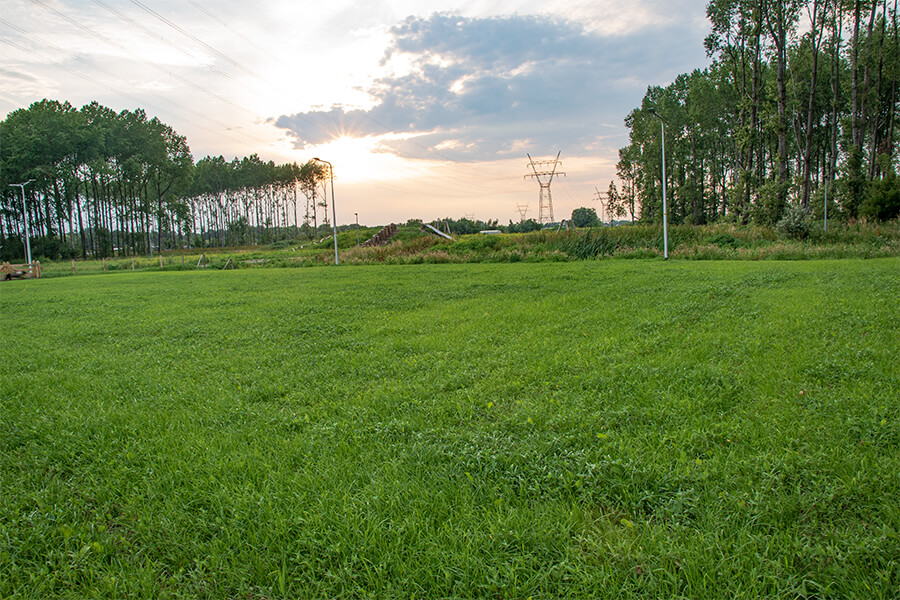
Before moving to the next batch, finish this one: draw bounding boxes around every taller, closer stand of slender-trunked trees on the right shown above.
[607,0,900,225]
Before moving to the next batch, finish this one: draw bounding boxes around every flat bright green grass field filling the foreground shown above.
[0,258,900,600]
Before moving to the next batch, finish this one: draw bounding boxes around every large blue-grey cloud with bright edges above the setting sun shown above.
[275,14,703,161]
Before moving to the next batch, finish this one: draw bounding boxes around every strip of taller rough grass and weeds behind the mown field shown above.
[19,220,900,277]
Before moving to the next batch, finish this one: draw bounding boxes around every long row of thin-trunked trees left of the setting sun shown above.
[0,99,329,260]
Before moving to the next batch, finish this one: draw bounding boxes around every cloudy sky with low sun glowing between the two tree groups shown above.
[0,0,708,224]
